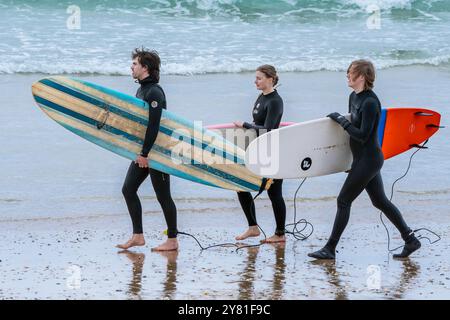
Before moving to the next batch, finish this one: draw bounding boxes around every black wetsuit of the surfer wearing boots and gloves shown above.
[326,90,411,252]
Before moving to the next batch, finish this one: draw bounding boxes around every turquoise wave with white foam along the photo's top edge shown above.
[1,0,450,19]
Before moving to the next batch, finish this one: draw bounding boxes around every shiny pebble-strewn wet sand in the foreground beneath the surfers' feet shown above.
[0,195,450,300]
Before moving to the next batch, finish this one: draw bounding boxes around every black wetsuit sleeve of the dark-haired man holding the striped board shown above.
[141,88,164,157]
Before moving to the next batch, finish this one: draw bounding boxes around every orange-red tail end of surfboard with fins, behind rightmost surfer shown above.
[378,108,441,159]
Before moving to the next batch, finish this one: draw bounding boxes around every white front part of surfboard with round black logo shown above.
[245,114,353,179]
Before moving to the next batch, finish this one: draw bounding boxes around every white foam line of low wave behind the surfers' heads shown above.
[0,55,450,76]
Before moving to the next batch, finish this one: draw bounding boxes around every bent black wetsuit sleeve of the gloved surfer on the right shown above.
[345,98,379,143]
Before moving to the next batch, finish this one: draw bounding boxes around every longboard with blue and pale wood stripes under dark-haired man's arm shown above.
[32,77,269,191]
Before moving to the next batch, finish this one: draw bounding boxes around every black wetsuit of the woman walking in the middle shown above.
[238,90,286,235]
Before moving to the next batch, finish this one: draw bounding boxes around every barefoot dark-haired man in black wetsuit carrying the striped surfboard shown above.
[117,49,178,251]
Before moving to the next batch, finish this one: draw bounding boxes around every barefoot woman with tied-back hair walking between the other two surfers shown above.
[234,65,286,243]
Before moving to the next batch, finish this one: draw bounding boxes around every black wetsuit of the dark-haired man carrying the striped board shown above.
[122,77,177,238]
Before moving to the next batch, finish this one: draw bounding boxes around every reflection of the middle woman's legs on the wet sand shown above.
[238,243,286,300]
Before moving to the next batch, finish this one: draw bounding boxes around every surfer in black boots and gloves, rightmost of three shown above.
[308,60,421,259]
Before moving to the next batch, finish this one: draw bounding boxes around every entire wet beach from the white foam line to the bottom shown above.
[0,67,450,299]
